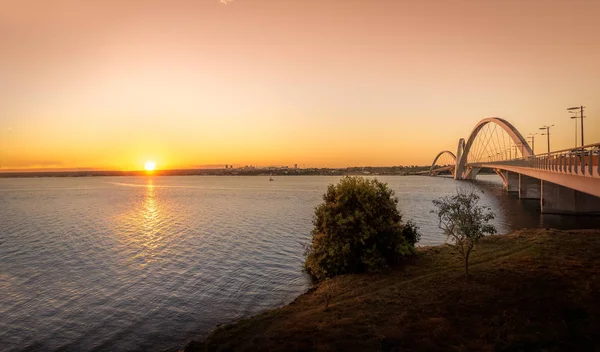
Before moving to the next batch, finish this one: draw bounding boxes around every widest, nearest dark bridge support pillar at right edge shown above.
[540,181,600,215]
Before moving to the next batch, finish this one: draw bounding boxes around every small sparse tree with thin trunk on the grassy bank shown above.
[432,189,496,278]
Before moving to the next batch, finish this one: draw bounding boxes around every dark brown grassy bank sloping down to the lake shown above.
[186,230,600,351]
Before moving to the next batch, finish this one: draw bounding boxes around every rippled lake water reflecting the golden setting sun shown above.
[0,176,598,351]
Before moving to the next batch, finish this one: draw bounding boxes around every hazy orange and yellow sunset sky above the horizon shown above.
[0,0,600,169]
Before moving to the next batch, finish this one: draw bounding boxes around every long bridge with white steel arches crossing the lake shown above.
[427,117,600,215]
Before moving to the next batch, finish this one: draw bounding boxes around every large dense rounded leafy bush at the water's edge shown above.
[304,177,420,280]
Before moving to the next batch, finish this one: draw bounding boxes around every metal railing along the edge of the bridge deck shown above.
[474,143,600,178]
